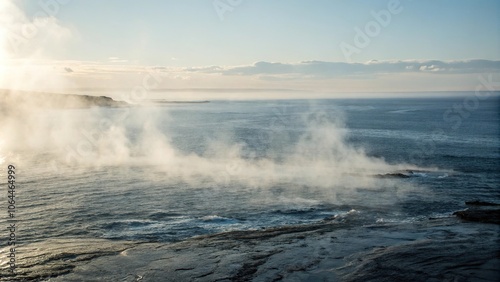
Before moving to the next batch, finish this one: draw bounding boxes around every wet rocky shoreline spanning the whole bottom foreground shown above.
[0,214,500,281]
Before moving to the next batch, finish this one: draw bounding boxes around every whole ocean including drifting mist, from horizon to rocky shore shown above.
[0,93,500,281]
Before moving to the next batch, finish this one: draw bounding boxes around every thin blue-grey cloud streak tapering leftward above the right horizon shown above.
[185,60,500,79]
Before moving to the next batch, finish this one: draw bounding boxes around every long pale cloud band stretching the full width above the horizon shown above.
[0,57,500,93]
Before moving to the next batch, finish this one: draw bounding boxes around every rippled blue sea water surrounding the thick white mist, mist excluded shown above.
[1,94,500,243]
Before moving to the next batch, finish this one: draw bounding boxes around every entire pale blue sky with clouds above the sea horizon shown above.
[0,0,500,96]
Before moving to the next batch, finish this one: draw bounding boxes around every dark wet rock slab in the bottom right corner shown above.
[340,234,499,282]
